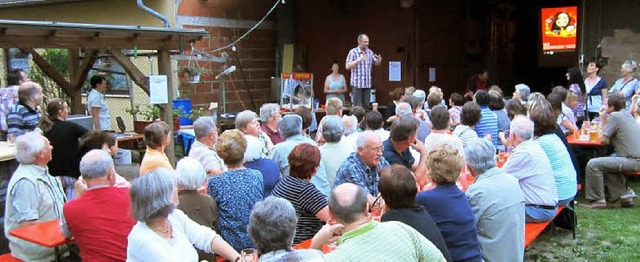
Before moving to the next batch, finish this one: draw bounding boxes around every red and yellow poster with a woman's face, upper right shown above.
[540,6,578,53]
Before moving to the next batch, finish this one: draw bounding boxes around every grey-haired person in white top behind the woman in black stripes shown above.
[319,115,348,185]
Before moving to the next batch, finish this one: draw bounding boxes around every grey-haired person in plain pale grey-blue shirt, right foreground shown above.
[464,138,524,261]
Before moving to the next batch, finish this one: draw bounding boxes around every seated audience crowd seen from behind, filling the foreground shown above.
[10,76,640,261]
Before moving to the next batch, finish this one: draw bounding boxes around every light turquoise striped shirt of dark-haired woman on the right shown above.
[536,133,578,200]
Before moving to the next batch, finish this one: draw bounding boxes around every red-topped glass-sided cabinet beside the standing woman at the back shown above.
[280,73,313,110]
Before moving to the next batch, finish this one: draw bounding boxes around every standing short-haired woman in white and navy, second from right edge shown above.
[584,62,607,119]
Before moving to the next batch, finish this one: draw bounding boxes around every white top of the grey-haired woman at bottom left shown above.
[127,209,220,262]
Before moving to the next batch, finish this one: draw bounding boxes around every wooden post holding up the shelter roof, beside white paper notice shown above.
[158,49,178,166]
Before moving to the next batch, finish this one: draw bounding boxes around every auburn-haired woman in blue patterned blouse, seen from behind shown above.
[208,129,264,250]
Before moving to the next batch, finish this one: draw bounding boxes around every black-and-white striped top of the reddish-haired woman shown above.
[272,176,327,245]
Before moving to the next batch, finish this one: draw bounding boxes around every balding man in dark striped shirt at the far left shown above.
[7,81,44,136]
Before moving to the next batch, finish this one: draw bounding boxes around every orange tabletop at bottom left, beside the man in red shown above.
[9,219,73,261]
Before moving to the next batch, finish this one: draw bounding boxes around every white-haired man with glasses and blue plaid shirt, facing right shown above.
[333,131,389,203]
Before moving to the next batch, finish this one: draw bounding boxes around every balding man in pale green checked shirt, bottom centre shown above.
[311,183,446,261]
